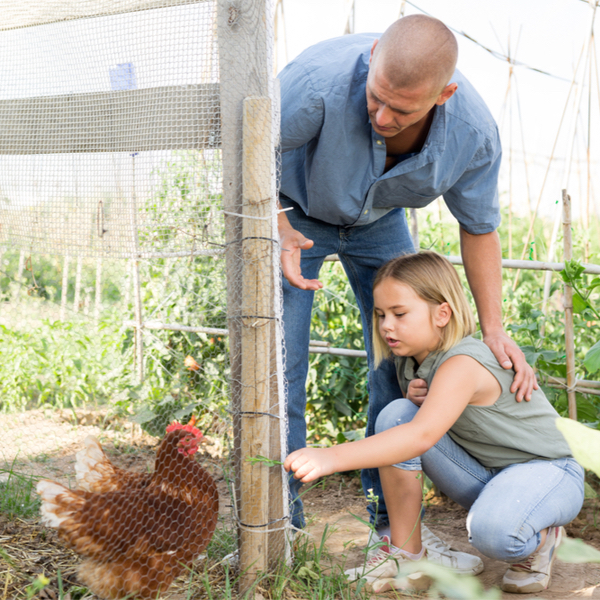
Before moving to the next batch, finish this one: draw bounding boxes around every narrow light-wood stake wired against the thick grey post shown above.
[239,97,279,592]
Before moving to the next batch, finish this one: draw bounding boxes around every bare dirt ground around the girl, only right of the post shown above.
[304,476,600,600]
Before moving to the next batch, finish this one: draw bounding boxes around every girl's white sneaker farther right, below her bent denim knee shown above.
[500,527,567,594]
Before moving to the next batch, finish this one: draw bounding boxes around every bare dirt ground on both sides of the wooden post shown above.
[0,411,600,600]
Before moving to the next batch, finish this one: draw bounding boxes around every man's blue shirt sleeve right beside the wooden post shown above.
[279,62,323,152]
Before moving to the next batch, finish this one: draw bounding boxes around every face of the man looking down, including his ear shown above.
[367,42,457,138]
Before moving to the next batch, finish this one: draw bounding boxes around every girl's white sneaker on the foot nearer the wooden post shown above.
[344,536,431,594]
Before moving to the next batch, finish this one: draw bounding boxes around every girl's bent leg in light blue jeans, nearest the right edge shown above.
[467,458,583,563]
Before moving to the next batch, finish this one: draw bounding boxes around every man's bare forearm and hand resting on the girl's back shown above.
[460,227,538,402]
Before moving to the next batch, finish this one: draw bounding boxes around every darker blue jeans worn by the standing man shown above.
[280,198,414,527]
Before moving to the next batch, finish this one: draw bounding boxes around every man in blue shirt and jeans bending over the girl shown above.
[279,15,537,572]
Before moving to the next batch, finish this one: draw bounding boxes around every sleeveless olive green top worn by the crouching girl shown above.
[396,336,572,468]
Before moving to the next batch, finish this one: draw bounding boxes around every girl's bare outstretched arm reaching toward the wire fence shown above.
[284,355,488,483]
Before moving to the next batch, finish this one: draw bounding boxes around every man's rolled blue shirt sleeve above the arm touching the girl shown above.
[444,128,502,235]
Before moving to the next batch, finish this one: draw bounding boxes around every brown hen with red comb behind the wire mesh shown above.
[37,423,219,599]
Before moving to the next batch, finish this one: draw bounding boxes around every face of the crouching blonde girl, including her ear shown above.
[373,277,452,364]
